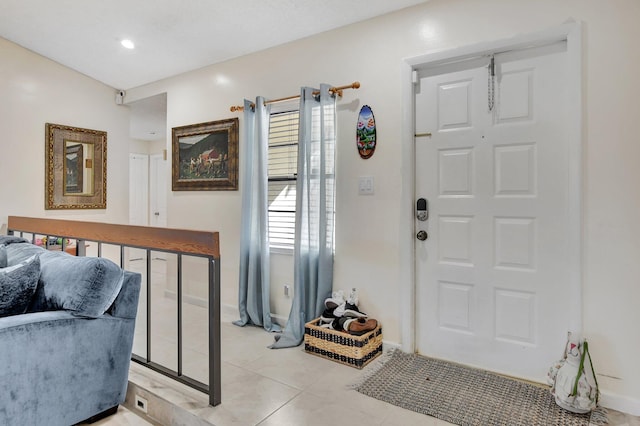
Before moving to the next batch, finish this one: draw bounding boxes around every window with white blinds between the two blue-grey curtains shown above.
[268,110,299,251]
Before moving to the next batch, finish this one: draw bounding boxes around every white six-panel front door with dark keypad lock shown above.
[415,43,580,381]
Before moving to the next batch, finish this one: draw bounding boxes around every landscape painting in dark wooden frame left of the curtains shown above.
[171,118,238,191]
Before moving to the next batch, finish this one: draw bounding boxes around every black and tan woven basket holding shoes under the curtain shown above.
[304,318,382,368]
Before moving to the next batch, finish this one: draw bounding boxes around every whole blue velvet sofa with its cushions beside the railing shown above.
[0,236,140,426]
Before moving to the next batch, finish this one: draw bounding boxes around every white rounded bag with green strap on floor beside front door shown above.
[547,333,599,413]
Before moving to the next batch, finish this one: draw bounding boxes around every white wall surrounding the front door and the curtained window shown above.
[114,0,640,414]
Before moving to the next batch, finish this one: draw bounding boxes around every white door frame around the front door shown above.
[399,22,582,352]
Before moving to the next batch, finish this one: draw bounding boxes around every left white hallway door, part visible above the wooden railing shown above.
[129,154,149,225]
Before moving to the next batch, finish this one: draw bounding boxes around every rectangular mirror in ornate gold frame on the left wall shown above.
[45,123,107,210]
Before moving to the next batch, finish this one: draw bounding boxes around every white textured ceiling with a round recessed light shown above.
[0,0,427,90]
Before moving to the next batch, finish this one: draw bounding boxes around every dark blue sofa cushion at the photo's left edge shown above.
[0,256,40,317]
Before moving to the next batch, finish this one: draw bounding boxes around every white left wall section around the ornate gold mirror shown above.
[0,38,129,223]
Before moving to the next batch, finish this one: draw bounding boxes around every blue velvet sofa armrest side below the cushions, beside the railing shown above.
[0,311,135,425]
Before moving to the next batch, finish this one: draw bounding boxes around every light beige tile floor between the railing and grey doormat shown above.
[99,300,640,426]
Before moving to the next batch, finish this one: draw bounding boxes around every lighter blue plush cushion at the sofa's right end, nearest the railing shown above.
[29,250,124,318]
